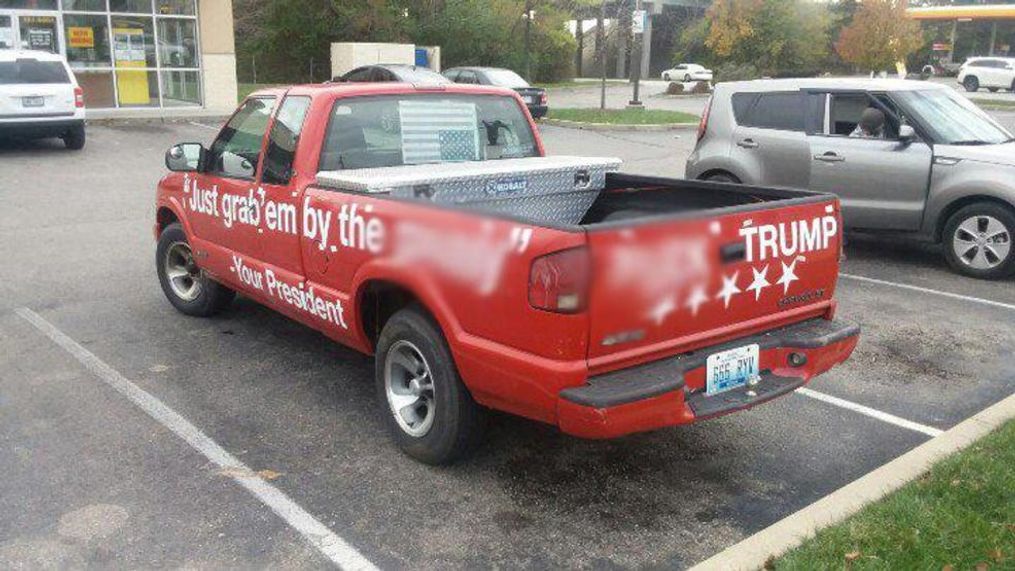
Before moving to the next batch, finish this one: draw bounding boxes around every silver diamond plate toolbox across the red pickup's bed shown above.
[317,156,621,224]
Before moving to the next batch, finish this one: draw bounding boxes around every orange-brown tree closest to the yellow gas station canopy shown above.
[835,0,924,71]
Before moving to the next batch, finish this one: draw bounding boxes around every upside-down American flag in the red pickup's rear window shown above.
[398,101,479,164]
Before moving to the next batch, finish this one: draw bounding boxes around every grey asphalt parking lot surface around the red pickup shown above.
[0,116,1015,569]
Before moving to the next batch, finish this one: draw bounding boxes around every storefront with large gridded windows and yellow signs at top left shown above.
[0,0,236,116]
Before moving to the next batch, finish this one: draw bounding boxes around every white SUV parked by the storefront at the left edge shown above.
[0,50,84,150]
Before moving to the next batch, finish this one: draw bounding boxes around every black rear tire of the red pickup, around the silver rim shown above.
[375,305,485,466]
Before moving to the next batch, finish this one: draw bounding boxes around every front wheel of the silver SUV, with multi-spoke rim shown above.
[943,202,1015,280]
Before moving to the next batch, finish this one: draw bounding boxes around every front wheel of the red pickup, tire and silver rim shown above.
[155,222,236,317]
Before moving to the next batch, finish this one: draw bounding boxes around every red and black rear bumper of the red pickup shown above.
[557,318,860,438]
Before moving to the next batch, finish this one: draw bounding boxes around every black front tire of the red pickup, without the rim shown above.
[155,222,236,317]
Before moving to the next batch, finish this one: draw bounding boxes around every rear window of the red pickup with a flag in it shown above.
[319,93,539,170]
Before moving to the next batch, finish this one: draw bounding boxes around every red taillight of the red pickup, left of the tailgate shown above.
[529,247,589,313]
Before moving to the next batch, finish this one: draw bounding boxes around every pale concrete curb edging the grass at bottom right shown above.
[691,395,1015,571]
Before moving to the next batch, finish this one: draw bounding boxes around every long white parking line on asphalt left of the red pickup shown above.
[15,307,377,570]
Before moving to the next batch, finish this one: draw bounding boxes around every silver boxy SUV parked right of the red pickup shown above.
[686,79,1015,279]
